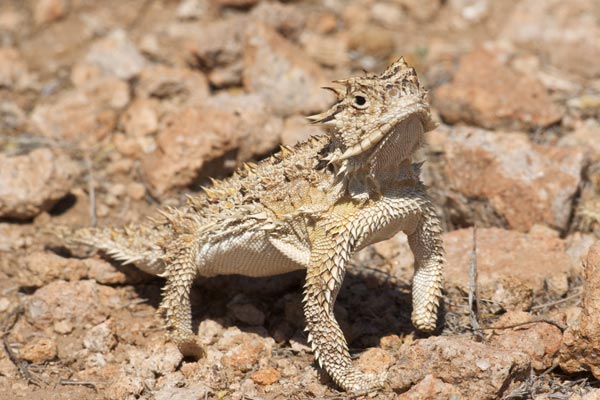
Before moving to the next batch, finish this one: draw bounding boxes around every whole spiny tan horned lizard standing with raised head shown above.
[55,59,443,392]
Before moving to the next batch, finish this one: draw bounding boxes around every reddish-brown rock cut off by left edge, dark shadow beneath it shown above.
[0,148,81,219]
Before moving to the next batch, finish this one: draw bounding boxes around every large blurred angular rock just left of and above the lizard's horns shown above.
[243,24,333,116]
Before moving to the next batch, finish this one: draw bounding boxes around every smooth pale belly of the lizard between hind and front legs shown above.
[198,230,310,277]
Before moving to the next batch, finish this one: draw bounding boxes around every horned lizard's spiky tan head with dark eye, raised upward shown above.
[309,58,435,163]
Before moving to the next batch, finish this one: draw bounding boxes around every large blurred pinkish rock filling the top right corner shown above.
[501,0,600,78]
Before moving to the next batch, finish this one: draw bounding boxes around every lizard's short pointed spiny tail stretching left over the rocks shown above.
[50,226,165,275]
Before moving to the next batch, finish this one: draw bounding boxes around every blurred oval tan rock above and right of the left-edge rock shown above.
[31,78,129,143]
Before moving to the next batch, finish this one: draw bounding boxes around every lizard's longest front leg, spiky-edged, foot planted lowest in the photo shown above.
[303,225,385,392]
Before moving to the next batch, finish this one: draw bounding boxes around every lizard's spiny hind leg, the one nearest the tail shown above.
[160,240,205,359]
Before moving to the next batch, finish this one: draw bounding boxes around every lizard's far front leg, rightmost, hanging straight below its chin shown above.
[407,198,444,332]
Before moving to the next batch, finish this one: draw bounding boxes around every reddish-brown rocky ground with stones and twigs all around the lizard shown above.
[0,0,600,400]
